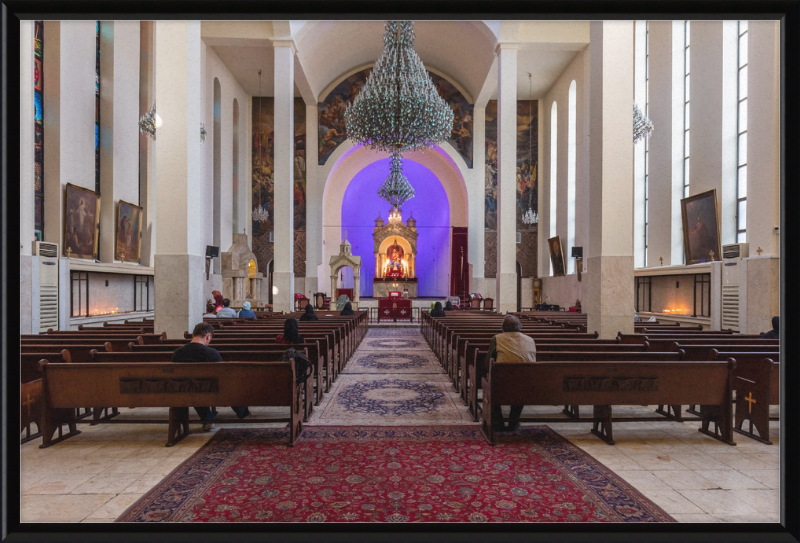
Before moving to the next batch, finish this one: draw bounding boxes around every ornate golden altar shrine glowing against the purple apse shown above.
[372,207,418,298]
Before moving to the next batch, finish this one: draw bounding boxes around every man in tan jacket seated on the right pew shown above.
[483,315,536,432]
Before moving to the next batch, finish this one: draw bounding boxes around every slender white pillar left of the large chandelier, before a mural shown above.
[272,40,294,312]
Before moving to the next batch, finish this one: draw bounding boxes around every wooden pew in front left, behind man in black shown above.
[39,361,303,448]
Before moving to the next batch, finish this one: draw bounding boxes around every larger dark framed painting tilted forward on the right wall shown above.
[681,190,722,264]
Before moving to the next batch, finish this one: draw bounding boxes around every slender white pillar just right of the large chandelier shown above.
[494,43,519,313]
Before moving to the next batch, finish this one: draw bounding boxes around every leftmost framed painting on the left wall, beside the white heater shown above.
[64,183,100,259]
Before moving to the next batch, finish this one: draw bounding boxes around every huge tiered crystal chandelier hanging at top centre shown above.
[344,21,453,152]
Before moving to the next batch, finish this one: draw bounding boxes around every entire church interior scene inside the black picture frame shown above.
[15,19,784,524]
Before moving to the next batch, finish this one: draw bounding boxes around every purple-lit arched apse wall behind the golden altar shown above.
[341,158,450,296]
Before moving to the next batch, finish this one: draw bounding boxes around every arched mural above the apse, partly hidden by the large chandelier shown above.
[316,68,474,168]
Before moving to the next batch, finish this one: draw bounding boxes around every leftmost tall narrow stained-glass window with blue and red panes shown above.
[33,21,44,241]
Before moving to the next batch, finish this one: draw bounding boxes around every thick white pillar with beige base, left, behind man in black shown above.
[155,21,203,338]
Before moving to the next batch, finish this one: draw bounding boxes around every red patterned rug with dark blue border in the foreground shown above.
[117,426,675,523]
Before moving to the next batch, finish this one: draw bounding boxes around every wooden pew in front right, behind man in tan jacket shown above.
[481,359,735,445]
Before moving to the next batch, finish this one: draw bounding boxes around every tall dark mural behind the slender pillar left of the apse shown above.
[252,97,306,277]
